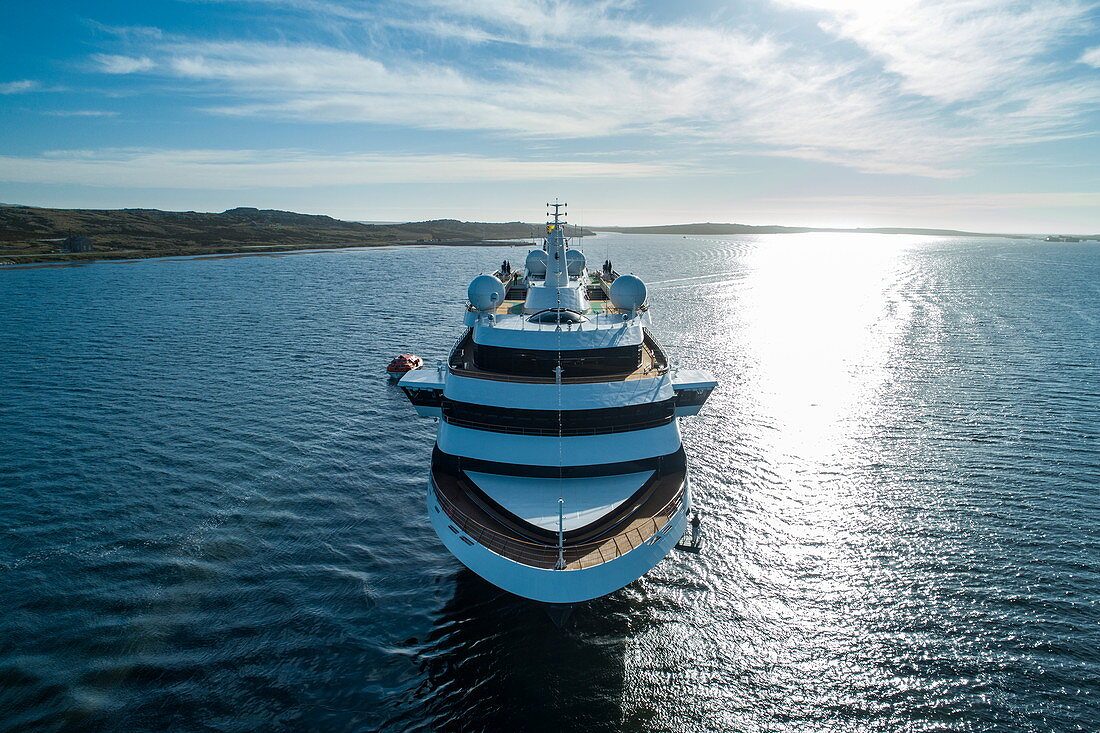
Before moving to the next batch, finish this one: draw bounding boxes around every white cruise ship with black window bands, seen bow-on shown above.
[398,204,716,605]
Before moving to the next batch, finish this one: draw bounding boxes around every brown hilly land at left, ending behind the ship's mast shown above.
[0,204,594,263]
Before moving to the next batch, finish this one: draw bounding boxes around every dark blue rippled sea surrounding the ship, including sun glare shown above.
[0,234,1100,732]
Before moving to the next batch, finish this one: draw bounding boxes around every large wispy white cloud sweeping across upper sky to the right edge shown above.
[66,0,1100,177]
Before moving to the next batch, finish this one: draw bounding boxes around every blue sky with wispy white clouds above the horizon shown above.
[0,0,1100,233]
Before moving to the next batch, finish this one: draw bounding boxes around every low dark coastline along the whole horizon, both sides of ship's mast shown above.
[0,205,1097,269]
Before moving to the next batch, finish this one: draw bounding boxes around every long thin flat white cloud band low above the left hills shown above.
[0,150,674,190]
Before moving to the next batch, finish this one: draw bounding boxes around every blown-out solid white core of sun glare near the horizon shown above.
[737,234,909,461]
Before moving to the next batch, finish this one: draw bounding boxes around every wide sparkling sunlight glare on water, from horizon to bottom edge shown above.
[625,234,1097,731]
